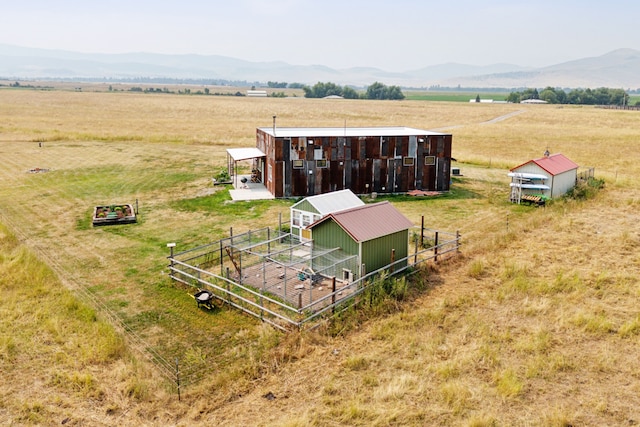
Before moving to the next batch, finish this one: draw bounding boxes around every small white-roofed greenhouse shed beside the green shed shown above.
[290,190,364,241]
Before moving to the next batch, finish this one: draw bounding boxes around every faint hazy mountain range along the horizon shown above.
[0,44,640,90]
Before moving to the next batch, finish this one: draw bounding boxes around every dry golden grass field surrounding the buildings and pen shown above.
[0,89,640,426]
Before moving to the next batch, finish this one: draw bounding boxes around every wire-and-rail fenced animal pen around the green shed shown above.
[169,227,460,330]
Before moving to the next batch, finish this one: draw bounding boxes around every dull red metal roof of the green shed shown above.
[310,201,413,242]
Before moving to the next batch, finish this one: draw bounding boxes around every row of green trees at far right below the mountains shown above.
[506,86,629,105]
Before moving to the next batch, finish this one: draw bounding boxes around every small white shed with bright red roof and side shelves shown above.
[509,152,578,203]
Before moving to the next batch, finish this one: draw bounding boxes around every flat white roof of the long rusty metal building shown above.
[258,126,445,138]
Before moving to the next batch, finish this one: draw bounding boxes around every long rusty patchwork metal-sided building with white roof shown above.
[248,126,452,197]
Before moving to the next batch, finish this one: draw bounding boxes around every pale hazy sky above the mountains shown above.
[0,0,640,71]
